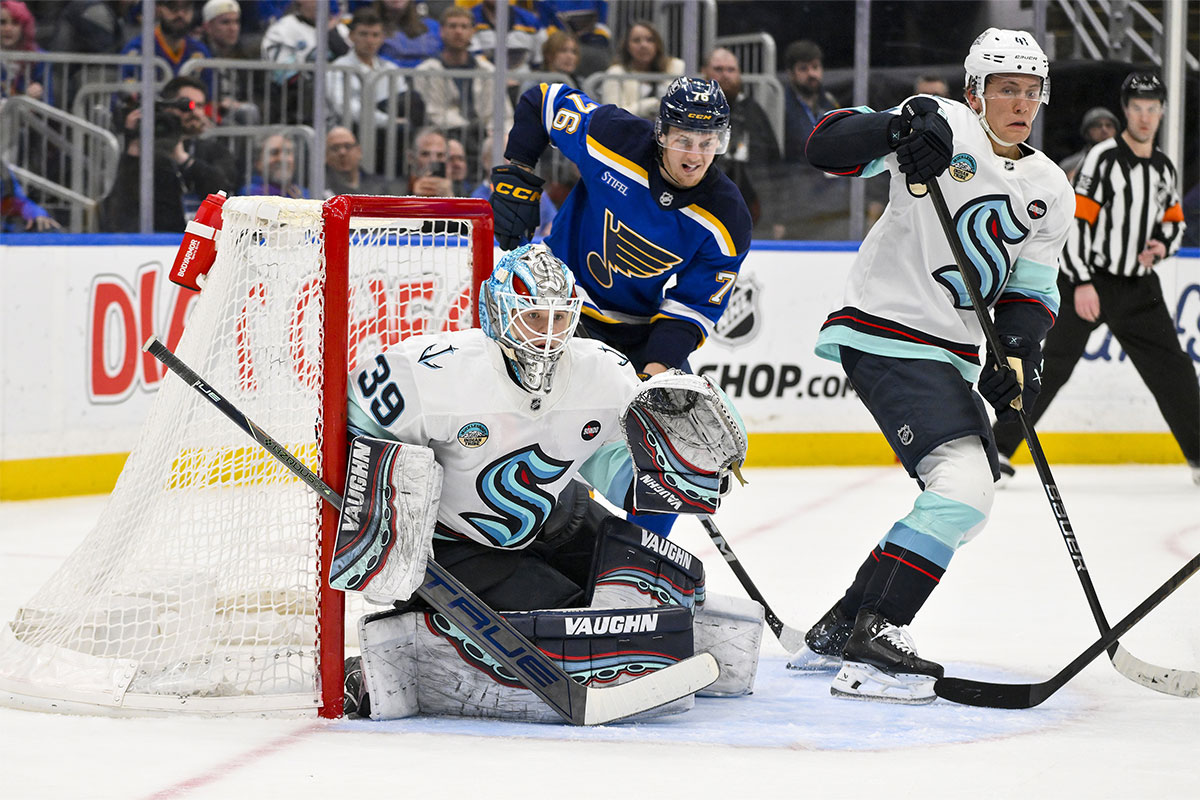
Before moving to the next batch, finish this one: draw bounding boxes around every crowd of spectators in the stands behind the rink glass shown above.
[0,0,1185,239]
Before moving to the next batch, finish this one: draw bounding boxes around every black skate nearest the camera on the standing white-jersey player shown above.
[829,608,943,704]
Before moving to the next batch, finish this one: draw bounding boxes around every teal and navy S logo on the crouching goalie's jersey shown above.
[461,445,571,547]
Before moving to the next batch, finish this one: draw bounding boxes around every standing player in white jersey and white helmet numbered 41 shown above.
[788,29,1074,703]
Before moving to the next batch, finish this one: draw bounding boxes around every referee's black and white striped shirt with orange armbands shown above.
[1061,136,1184,284]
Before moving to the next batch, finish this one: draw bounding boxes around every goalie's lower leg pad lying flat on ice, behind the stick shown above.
[360,607,695,723]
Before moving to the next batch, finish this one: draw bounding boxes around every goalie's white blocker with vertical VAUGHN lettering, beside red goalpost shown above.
[329,437,442,603]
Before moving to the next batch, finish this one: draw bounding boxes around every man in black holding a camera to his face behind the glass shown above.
[160,76,241,195]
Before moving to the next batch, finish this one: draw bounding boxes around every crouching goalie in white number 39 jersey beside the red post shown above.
[336,245,761,718]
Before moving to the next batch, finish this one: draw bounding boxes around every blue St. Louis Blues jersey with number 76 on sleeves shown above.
[505,84,751,363]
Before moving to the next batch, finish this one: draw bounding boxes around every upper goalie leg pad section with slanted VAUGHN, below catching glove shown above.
[590,517,704,609]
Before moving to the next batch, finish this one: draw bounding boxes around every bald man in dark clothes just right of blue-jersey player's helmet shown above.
[702,47,779,224]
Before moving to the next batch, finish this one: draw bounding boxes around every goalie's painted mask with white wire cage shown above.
[479,245,582,395]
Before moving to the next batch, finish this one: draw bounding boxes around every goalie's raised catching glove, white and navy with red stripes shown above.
[620,369,746,513]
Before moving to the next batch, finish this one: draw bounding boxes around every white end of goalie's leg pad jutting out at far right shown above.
[694,594,764,697]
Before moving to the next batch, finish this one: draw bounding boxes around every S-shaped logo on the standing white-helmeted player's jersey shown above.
[934,194,1030,308]
